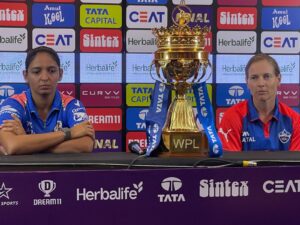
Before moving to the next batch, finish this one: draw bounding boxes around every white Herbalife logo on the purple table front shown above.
[76,181,143,201]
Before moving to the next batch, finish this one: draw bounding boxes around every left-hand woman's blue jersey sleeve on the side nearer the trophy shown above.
[65,99,88,127]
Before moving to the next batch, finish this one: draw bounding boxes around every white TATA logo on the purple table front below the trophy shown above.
[157,177,185,202]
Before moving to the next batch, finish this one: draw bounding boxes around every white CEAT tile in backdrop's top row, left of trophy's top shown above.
[126,6,168,28]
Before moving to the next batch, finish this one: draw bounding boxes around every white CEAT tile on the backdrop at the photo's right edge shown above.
[261,31,300,53]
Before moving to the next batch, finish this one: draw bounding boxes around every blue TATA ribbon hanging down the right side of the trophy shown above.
[193,82,223,157]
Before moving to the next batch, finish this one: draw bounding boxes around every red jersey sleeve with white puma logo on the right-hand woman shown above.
[218,105,242,151]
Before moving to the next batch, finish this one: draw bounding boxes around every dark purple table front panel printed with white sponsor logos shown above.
[0,166,300,225]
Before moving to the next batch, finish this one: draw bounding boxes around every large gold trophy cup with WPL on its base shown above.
[151,1,210,157]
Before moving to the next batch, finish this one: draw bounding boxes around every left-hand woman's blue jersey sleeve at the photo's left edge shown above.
[0,98,25,124]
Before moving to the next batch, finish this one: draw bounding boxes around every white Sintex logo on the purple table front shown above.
[199,179,249,198]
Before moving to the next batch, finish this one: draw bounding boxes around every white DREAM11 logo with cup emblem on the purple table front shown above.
[33,180,62,206]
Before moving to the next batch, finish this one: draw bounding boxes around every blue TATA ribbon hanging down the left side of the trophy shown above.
[145,81,171,156]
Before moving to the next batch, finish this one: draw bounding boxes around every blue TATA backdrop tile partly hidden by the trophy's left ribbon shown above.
[126,107,149,131]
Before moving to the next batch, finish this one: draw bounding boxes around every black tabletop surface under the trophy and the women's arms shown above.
[0,151,300,171]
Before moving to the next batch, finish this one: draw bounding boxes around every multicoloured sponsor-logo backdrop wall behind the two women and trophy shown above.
[0,0,300,152]
